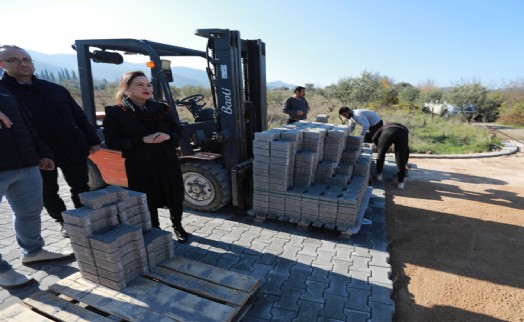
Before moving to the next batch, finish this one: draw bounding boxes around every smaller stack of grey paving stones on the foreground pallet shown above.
[62,186,174,290]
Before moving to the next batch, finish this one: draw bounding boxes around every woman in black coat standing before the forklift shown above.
[104,71,188,242]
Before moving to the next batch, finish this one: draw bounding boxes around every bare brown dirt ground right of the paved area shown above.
[386,132,524,322]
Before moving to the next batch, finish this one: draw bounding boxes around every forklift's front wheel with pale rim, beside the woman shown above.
[181,161,231,212]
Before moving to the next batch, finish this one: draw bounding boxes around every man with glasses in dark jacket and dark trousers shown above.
[0,46,100,237]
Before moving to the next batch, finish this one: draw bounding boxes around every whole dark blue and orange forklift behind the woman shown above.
[73,29,267,212]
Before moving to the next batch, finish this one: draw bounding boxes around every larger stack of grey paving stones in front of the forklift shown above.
[253,121,372,230]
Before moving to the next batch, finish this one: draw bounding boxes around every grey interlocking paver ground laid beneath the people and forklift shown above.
[0,170,395,322]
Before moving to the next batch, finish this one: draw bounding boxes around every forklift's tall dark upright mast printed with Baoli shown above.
[196,29,267,170]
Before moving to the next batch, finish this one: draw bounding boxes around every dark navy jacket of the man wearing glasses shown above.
[0,72,100,166]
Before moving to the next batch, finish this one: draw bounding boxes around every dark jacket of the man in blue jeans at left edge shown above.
[0,85,53,171]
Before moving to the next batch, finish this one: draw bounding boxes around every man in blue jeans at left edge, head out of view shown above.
[0,85,73,288]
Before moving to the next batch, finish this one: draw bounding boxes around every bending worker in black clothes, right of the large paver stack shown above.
[373,122,409,189]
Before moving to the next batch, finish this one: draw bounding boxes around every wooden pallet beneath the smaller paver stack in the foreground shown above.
[7,258,261,322]
